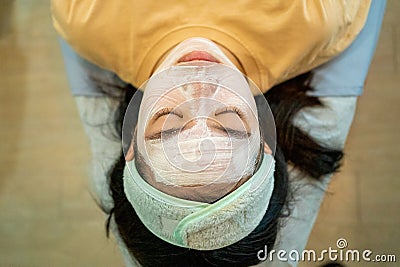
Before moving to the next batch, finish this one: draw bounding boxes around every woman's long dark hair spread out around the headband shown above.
[107,73,343,266]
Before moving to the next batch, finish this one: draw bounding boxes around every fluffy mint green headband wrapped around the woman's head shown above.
[124,154,275,250]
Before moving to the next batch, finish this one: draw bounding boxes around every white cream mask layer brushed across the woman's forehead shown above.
[146,120,260,186]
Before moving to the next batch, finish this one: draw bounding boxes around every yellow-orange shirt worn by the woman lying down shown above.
[52,0,371,92]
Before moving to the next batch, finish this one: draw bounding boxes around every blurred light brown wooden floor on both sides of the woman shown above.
[0,0,400,266]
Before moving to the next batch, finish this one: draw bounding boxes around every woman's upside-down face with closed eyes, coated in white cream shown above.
[130,38,261,201]
